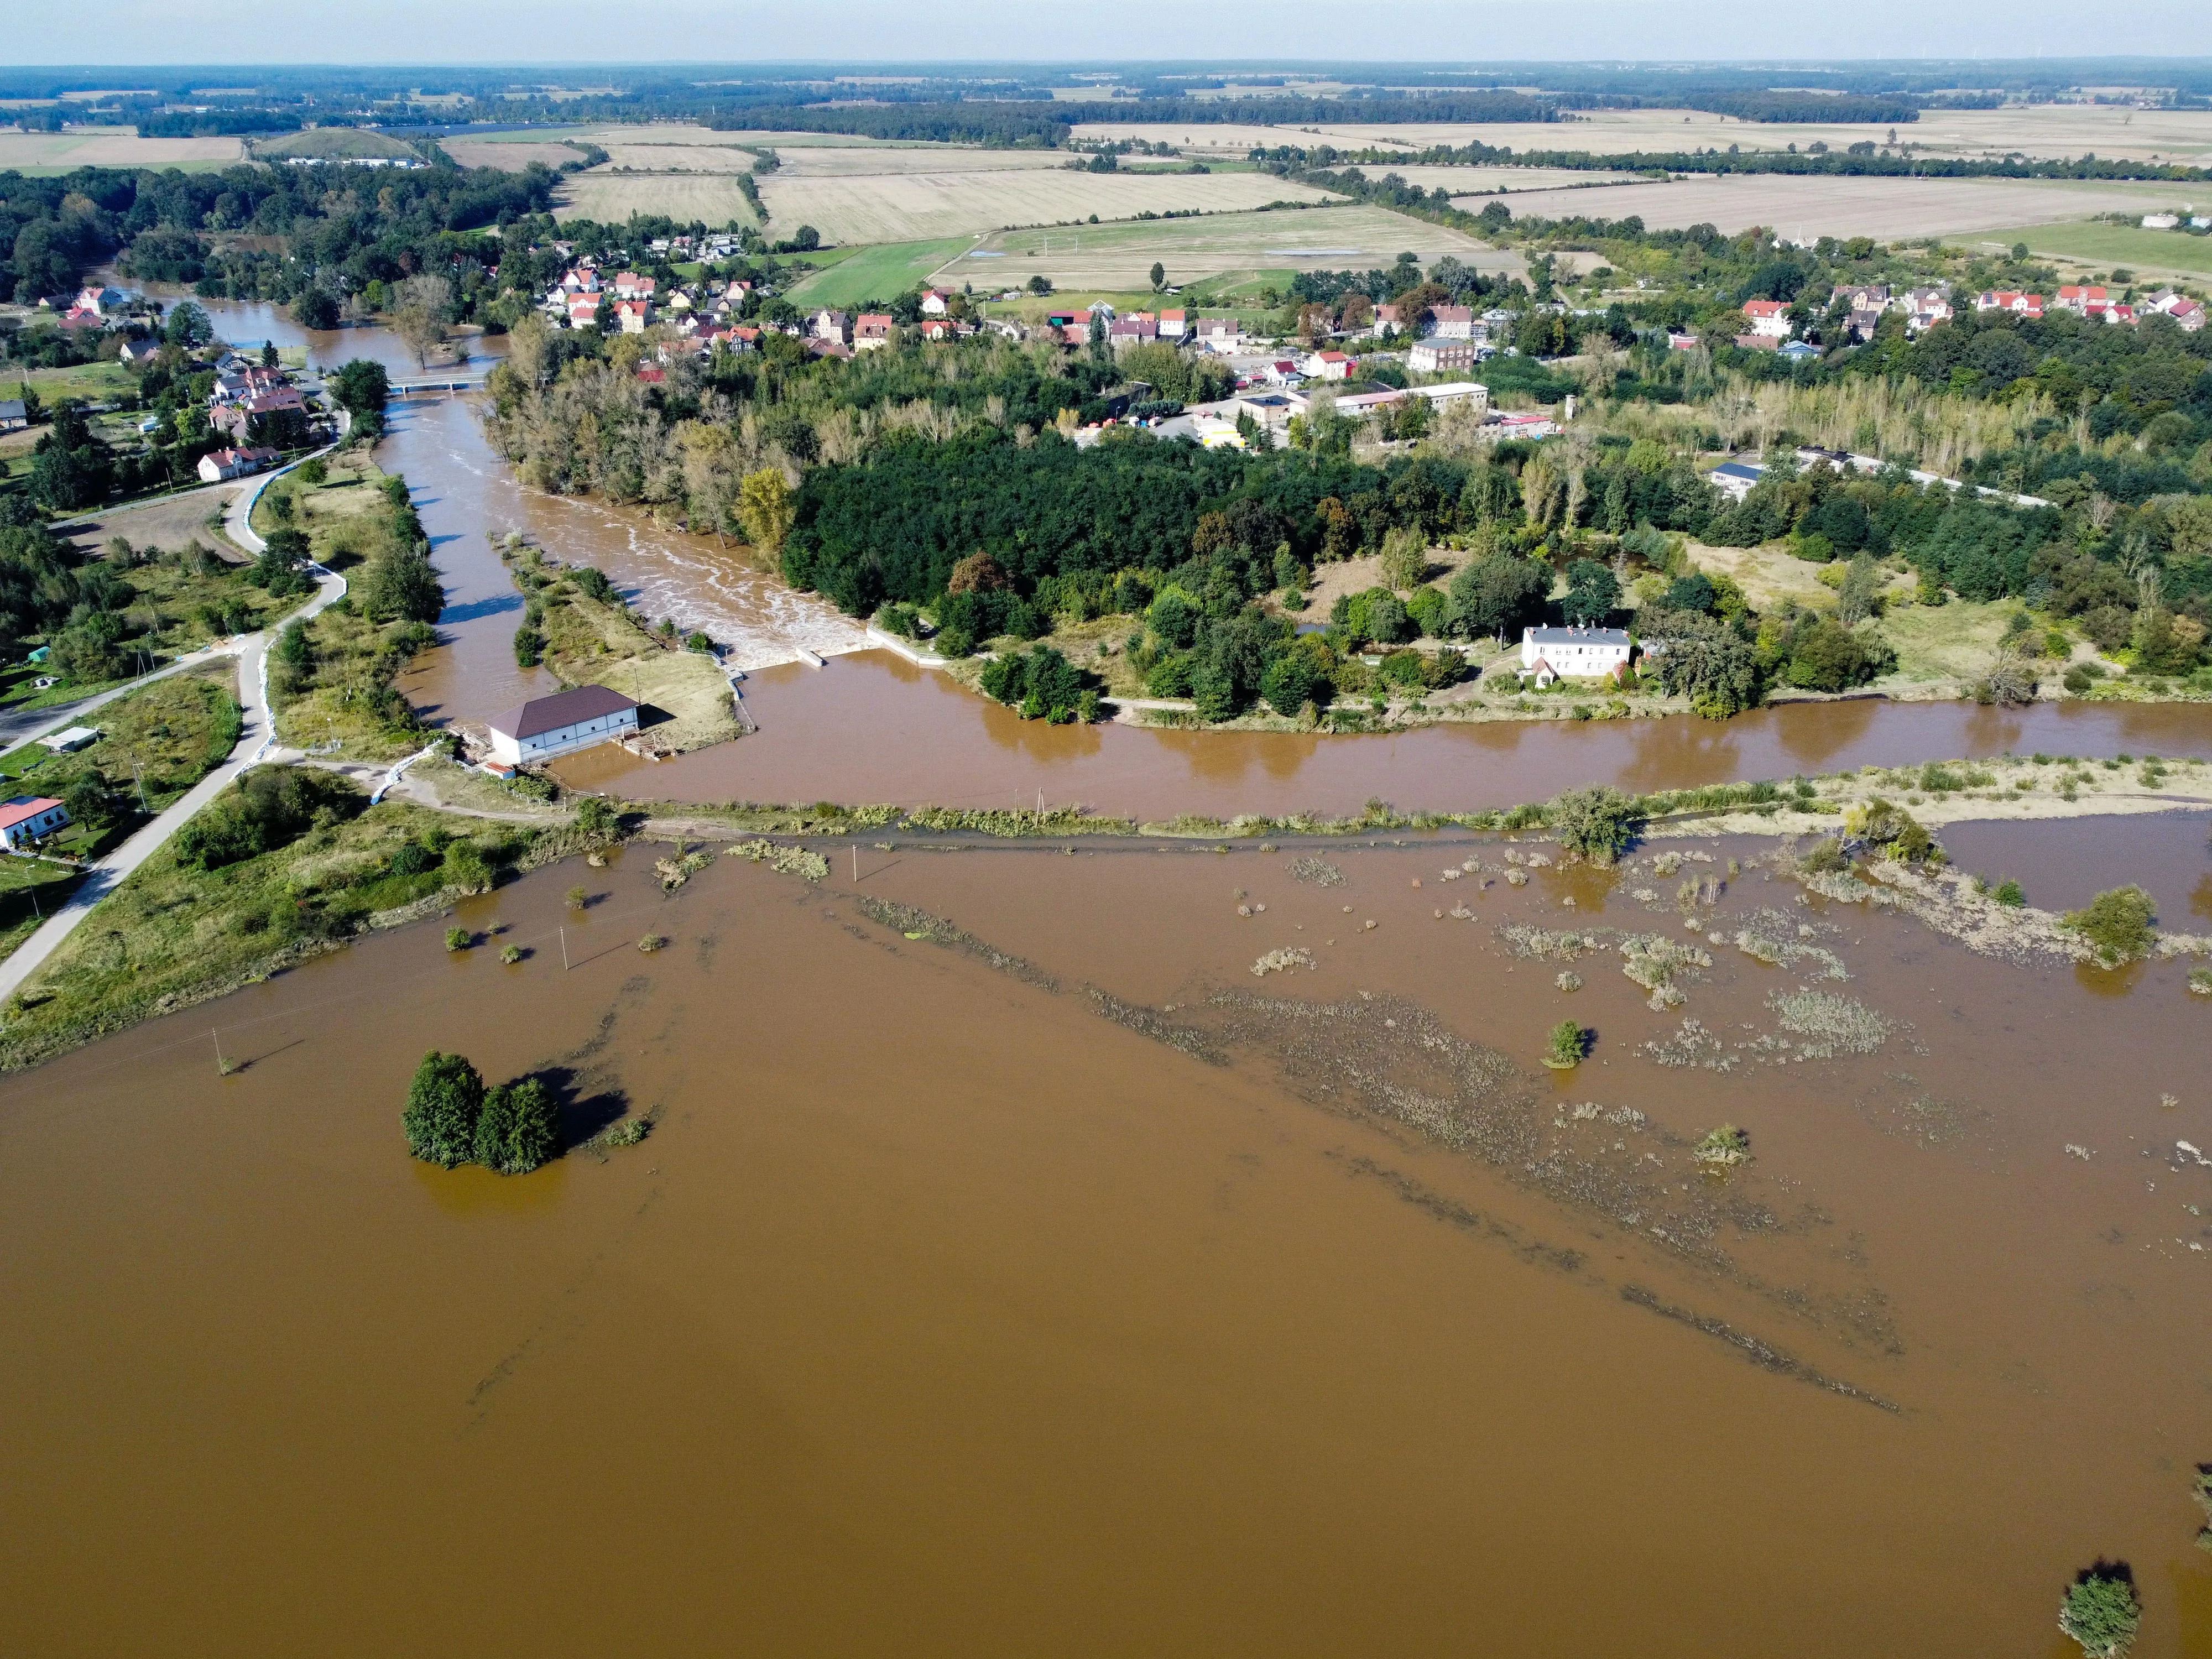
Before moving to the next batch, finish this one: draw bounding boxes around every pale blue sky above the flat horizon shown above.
[13,0,2212,66]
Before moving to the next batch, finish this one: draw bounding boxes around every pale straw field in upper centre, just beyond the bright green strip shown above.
[761,168,1329,243]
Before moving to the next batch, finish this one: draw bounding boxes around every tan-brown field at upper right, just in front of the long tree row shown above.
[1455,173,2174,241]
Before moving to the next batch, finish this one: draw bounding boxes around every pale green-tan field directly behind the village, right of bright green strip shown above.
[940,204,1520,292]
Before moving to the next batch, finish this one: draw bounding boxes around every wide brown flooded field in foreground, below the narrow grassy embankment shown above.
[0,841,2212,1659]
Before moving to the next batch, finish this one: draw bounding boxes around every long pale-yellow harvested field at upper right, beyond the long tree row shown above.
[1075,104,2212,166]
